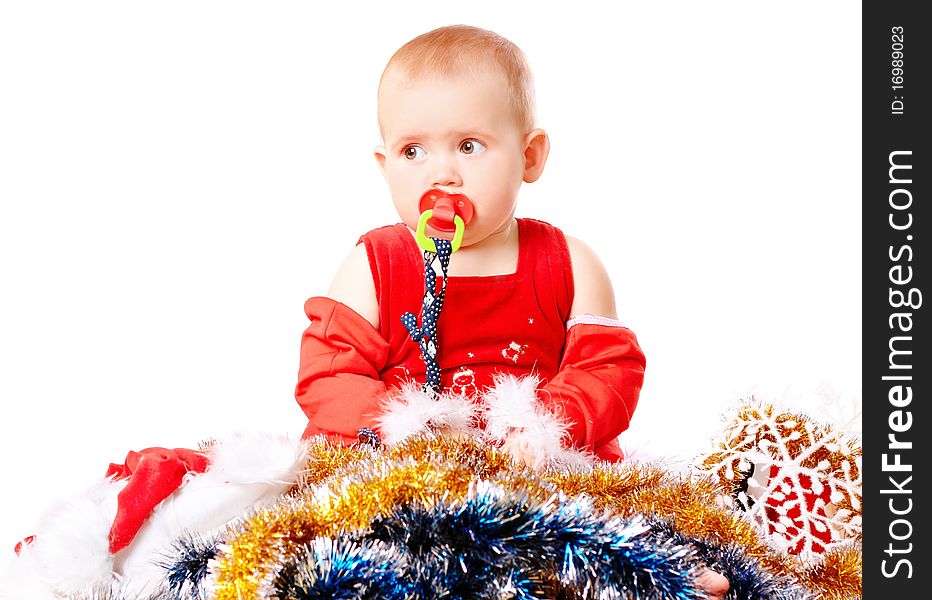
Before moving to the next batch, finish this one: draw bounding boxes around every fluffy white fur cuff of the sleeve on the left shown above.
[376,383,477,444]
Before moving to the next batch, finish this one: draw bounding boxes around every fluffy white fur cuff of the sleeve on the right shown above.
[482,375,592,468]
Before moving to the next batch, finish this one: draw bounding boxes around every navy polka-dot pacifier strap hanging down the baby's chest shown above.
[401,238,453,396]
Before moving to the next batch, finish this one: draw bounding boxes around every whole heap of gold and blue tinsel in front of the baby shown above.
[160,436,861,600]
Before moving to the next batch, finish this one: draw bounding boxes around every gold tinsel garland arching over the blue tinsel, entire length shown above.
[213,436,861,600]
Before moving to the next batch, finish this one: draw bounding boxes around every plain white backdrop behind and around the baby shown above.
[0,1,861,562]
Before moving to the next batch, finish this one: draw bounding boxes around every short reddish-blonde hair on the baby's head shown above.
[379,25,535,133]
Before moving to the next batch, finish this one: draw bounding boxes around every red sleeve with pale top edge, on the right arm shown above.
[538,322,646,456]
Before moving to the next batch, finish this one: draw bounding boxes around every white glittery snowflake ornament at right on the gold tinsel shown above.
[695,398,861,555]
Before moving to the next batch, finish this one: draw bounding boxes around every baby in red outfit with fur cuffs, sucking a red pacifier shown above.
[295,26,645,465]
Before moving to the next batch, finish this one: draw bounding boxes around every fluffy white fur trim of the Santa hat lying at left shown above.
[0,433,307,600]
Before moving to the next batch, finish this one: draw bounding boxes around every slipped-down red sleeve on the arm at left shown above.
[295,297,388,443]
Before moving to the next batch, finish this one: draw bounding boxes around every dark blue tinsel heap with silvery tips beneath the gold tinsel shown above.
[277,484,703,600]
